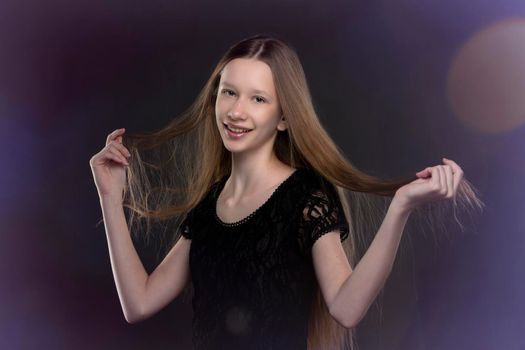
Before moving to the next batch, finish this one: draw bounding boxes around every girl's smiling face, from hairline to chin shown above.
[215,58,286,152]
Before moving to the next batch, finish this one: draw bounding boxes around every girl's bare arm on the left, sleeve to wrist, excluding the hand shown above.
[100,196,191,323]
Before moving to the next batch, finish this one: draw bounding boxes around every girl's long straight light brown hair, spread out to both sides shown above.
[118,35,483,350]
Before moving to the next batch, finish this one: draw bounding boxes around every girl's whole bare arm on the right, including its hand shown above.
[312,158,463,328]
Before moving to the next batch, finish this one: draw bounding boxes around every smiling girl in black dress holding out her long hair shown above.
[90,35,482,349]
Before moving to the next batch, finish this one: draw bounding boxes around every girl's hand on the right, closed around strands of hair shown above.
[394,158,463,211]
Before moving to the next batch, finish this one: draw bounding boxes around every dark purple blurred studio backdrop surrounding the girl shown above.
[0,0,525,350]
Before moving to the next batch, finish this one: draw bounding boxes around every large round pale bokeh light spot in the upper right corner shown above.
[447,19,525,133]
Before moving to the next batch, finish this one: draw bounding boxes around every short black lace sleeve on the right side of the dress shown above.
[298,180,349,255]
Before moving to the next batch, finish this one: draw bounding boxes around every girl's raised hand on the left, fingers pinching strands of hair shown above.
[89,128,131,200]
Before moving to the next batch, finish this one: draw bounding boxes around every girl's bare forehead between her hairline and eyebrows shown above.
[220,58,275,94]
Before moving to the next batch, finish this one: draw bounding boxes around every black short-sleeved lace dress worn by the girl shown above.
[180,168,348,350]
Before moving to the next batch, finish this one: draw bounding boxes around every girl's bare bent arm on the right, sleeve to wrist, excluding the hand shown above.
[312,199,410,328]
